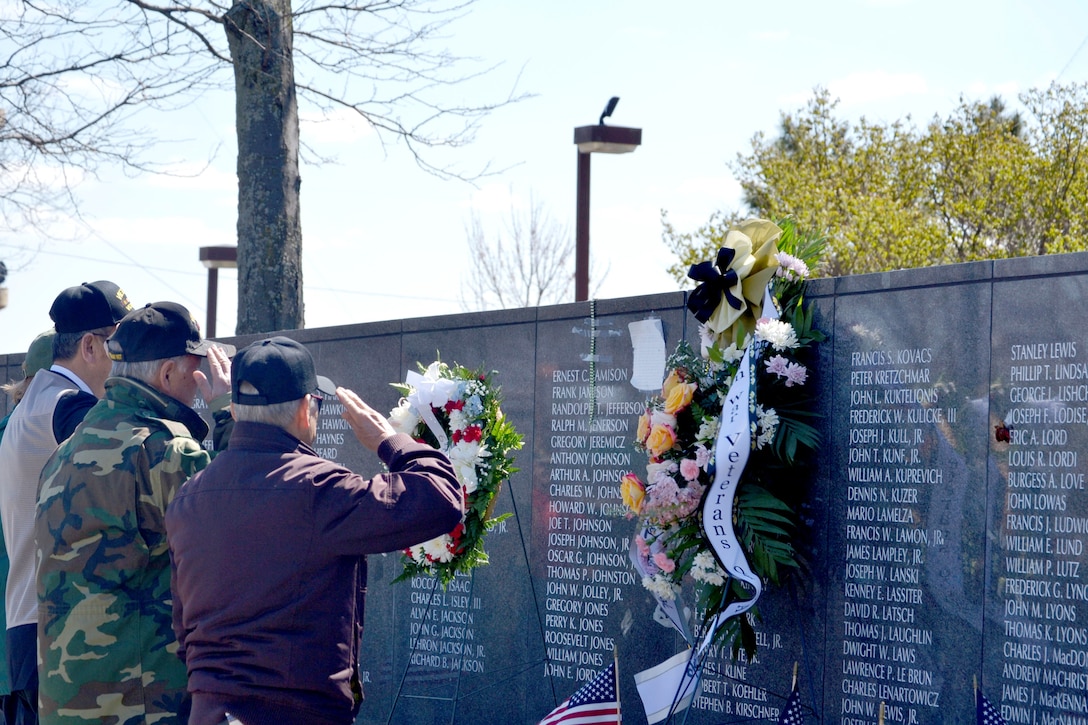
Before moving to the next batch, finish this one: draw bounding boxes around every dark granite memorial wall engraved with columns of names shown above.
[0,254,1088,725]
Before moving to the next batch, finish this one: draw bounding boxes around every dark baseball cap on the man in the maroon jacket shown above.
[231,335,336,405]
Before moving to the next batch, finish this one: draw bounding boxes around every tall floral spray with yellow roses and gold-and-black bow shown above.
[620,214,825,658]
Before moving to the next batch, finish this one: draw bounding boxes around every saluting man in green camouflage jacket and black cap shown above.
[35,303,233,725]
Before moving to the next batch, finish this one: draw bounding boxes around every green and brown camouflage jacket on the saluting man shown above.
[36,396,209,725]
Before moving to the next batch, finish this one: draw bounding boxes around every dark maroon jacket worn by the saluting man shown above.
[166,422,462,723]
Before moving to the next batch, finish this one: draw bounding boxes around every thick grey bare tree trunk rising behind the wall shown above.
[224,0,305,334]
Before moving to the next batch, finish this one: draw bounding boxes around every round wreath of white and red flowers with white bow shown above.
[390,360,522,588]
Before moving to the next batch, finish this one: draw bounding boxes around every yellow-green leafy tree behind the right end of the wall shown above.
[663,84,1088,283]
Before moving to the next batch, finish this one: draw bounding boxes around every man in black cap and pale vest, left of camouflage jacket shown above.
[0,280,132,723]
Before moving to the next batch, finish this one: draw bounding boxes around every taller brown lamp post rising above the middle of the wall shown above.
[574,96,642,302]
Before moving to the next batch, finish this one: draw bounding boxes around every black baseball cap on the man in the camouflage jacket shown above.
[106,302,234,363]
